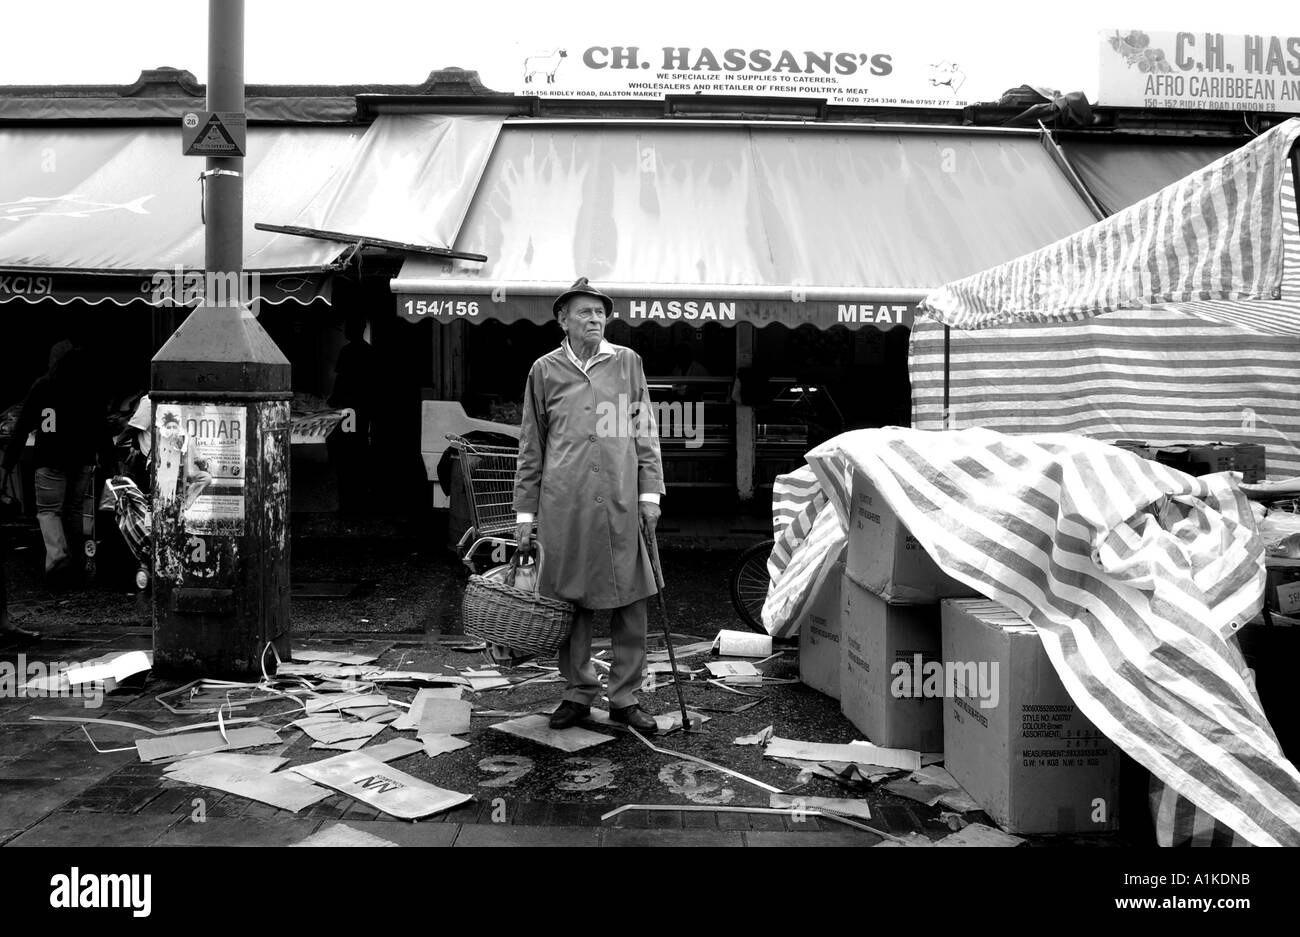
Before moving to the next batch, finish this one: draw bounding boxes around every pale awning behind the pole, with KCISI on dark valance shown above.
[0,116,501,304]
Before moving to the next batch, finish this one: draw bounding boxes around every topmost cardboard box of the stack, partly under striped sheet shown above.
[846,472,975,604]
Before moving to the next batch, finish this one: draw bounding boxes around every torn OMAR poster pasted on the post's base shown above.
[155,404,247,535]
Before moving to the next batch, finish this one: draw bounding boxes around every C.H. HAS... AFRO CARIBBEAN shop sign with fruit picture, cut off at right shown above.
[1097,30,1300,113]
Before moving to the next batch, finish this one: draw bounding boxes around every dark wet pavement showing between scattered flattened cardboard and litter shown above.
[0,522,1138,846]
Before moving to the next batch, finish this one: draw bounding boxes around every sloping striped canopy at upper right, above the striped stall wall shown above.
[922,118,1300,334]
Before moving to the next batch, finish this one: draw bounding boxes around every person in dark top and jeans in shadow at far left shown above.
[4,340,111,589]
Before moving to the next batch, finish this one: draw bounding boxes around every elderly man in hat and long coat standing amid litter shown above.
[515,277,664,732]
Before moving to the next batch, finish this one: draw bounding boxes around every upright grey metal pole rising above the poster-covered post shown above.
[203,0,244,274]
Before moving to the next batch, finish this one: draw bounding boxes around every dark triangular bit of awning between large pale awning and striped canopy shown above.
[1060,140,1236,214]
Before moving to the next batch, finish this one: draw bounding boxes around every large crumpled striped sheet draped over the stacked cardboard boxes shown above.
[807,429,1300,845]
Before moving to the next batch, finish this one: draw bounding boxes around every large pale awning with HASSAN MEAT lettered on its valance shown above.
[393,121,1095,329]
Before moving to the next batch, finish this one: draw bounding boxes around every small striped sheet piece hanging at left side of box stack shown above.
[763,465,845,638]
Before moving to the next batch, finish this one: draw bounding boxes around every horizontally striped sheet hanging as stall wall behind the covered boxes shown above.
[909,308,1300,478]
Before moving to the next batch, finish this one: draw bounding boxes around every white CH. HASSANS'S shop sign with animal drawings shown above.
[506,38,969,107]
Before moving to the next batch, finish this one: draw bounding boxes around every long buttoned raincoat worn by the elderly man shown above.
[515,344,664,608]
